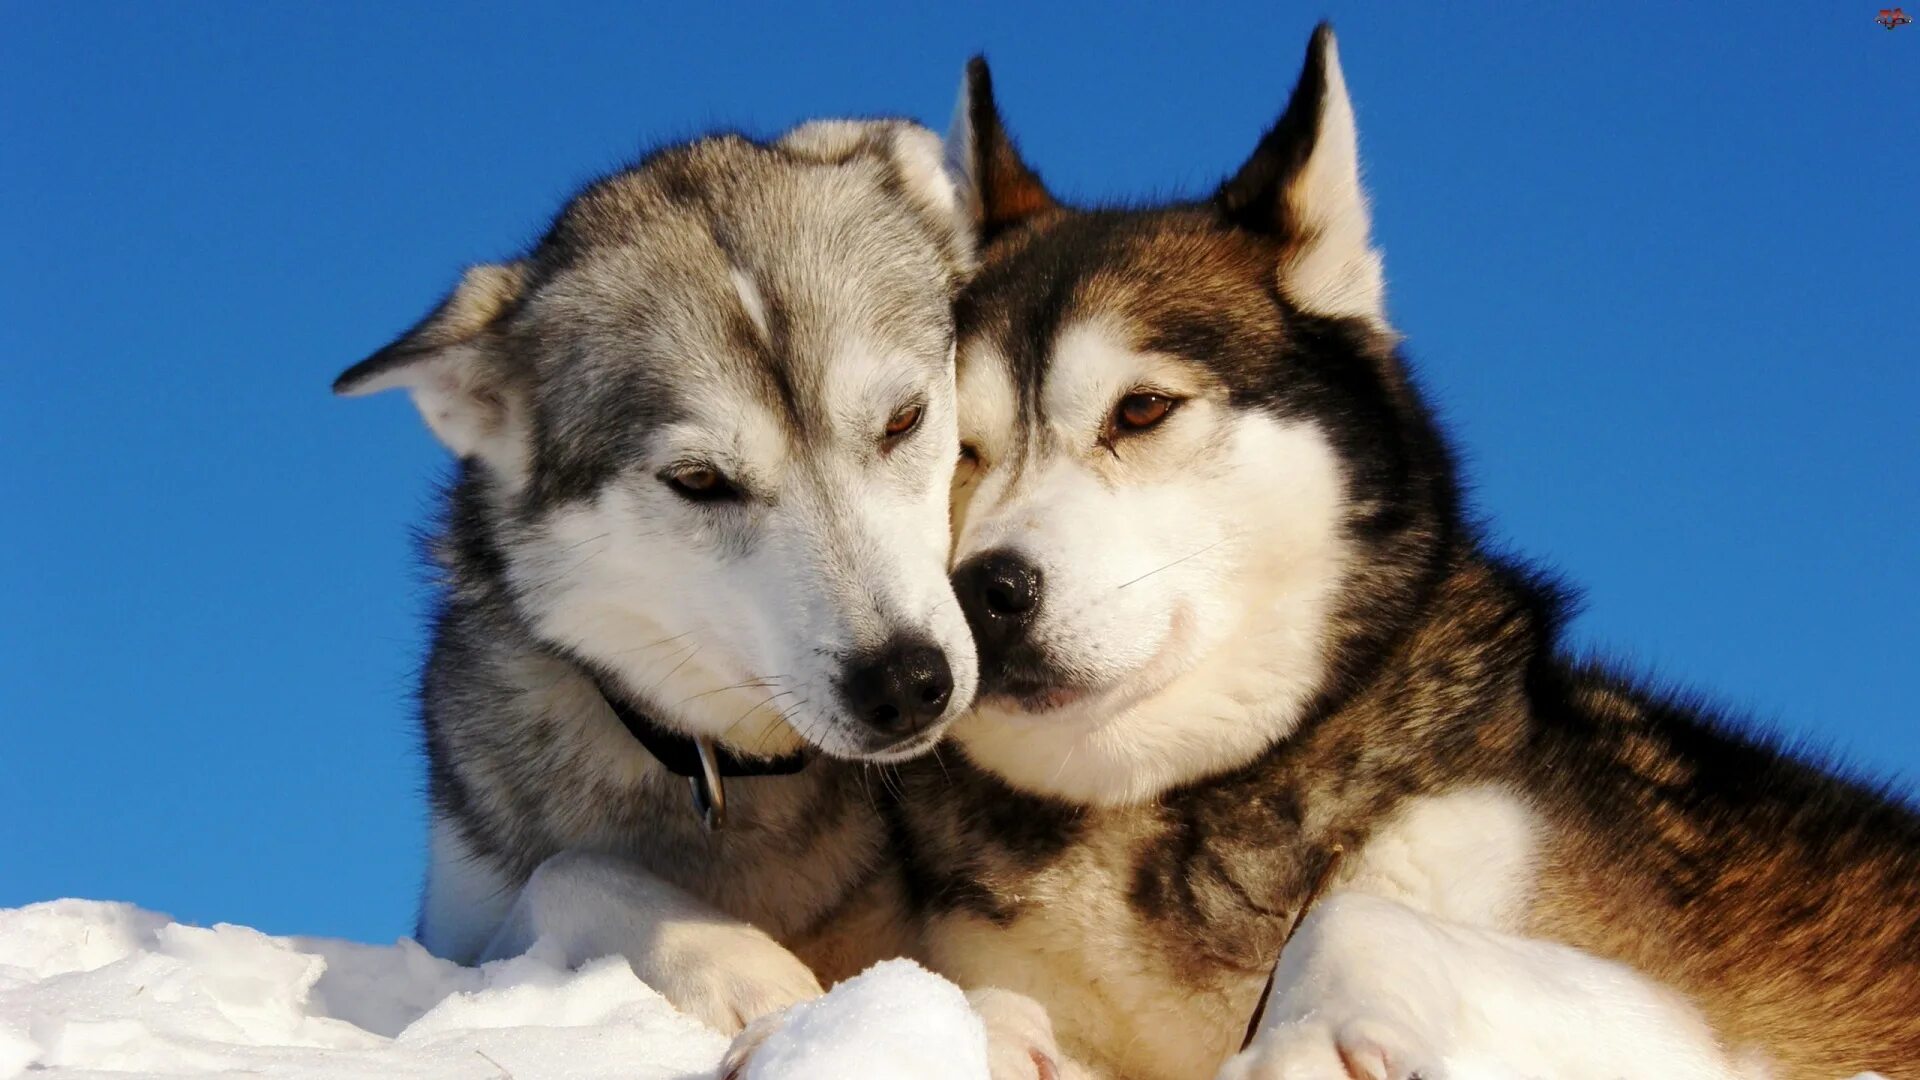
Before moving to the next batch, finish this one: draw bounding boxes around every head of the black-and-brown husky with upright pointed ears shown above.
[950,27,1452,803]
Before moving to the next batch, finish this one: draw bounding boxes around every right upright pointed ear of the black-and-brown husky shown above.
[1213,23,1386,323]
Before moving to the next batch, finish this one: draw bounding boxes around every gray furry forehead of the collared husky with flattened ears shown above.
[520,160,950,453]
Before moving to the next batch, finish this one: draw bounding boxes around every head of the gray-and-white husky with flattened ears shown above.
[334,121,975,759]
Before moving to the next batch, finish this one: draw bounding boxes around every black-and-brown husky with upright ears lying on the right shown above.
[871,27,1920,1080]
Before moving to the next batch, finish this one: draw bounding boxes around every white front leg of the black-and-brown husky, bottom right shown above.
[1217,892,1764,1080]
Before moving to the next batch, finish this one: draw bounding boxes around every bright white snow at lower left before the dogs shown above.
[0,899,985,1080]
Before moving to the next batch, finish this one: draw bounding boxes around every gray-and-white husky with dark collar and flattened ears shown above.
[334,121,975,1030]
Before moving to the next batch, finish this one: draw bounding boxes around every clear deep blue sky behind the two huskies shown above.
[0,2,1920,940]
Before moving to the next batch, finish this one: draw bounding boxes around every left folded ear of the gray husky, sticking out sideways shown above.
[334,263,528,488]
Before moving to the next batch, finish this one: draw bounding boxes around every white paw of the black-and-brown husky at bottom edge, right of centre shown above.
[1215,1019,1446,1080]
